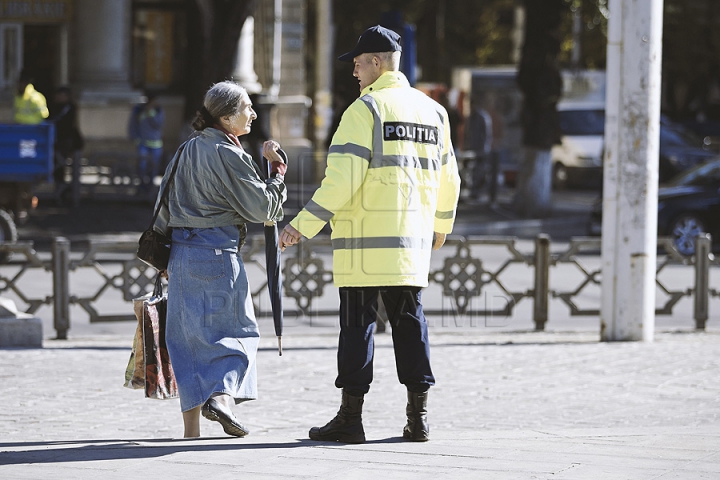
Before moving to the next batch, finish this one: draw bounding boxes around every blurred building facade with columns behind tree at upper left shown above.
[0,0,309,163]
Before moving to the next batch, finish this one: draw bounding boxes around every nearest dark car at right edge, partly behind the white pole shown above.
[589,160,720,255]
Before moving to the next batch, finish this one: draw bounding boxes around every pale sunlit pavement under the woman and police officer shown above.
[0,328,720,480]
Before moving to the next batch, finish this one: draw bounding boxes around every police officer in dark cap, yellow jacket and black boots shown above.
[280,26,460,443]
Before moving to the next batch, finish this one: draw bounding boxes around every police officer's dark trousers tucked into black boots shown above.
[335,287,435,396]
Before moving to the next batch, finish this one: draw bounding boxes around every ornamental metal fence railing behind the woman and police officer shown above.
[0,234,720,339]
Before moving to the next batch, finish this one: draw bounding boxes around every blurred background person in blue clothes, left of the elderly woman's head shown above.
[128,92,165,189]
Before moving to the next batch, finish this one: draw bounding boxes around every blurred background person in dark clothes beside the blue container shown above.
[48,86,85,195]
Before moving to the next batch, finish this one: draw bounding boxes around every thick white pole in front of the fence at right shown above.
[600,0,663,342]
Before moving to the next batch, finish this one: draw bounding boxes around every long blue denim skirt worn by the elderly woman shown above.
[166,227,260,412]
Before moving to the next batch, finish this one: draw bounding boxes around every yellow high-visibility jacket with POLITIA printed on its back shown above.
[290,72,460,287]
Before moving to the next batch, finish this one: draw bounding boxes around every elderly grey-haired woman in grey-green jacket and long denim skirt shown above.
[158,82,287,438]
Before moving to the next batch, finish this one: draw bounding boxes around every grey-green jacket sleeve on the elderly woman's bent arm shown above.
[218,146,287,223]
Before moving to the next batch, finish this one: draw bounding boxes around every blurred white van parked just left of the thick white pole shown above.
[551,100,605,188]
